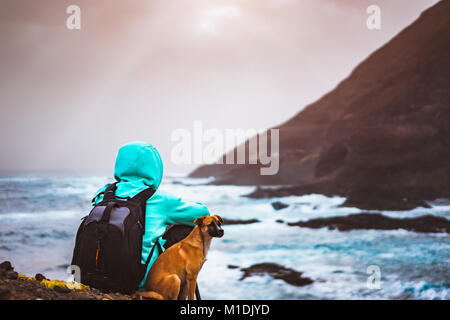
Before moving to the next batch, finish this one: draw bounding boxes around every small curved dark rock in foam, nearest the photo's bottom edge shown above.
[240,263,314,287]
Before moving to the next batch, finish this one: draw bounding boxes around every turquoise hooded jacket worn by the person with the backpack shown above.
[94,142,210,288]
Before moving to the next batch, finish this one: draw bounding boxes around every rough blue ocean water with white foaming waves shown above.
[0,174,450,299]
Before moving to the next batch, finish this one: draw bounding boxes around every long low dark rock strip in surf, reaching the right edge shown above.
[288,213,450,233]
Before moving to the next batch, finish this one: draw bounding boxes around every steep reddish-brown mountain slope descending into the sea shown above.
[191,1,450,210]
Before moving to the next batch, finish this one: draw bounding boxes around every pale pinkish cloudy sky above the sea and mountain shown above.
[0,0,437,172]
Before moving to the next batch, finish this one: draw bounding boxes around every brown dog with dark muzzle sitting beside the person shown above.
[137,215,224,300]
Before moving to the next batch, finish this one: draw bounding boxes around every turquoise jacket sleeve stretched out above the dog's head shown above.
[166,191,210,226]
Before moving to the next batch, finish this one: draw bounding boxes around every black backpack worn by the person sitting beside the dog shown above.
[72,183,162,294]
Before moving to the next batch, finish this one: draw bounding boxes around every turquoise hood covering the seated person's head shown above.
[114,142,163,193]
